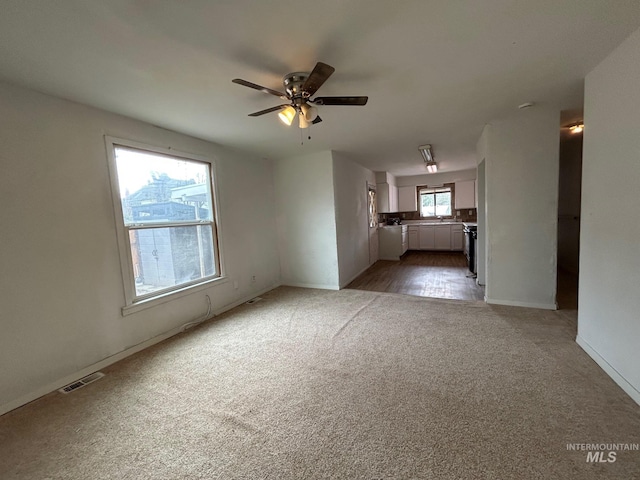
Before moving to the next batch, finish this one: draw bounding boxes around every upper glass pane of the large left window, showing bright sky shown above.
[115,147,213,225]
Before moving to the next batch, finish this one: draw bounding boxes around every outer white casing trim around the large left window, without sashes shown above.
[104,135,227,316]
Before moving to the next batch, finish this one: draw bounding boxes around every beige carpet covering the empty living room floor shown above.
[0,288,640,480]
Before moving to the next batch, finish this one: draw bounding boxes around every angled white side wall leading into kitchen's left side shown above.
[332,152,376,288]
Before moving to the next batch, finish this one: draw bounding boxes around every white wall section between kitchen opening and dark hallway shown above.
[485,106,560,309]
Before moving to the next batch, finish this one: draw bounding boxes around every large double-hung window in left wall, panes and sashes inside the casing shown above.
[108,141,220,304]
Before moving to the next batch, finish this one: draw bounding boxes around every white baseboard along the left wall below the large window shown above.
[0,284,280,415]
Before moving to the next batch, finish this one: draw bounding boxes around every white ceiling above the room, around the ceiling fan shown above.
[0,0,640,175]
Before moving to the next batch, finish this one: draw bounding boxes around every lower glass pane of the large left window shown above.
[129,225,216,296]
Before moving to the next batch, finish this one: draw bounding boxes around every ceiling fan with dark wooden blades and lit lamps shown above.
[232,62,369,128]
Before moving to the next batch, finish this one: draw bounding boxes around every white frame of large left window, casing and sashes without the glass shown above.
[104,135,227,316]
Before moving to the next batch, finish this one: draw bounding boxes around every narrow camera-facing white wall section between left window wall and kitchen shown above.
[274,151,340,289]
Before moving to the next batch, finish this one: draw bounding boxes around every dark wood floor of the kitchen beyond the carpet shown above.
[346,251,484,300]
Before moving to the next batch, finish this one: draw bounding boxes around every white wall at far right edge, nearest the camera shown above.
[577,30,640,403]
